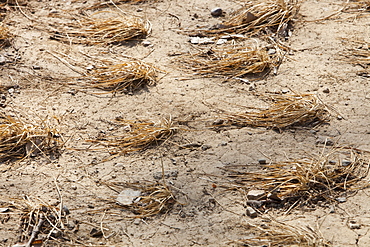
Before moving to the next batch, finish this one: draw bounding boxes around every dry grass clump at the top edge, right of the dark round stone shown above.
[189,0,299,36]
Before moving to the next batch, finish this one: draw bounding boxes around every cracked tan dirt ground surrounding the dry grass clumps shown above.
[0,0,370,246]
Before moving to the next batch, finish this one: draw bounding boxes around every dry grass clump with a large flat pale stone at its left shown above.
[106,179,176,218]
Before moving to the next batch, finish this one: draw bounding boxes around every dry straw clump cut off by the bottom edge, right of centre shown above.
[232,221,332,247]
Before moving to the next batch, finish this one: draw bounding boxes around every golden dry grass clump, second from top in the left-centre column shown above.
[87,60,159,93]
